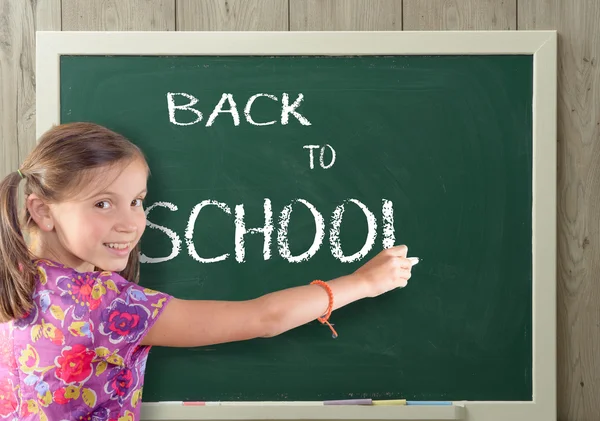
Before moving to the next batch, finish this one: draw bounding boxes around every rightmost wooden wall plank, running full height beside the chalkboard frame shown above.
[519,0,600,421]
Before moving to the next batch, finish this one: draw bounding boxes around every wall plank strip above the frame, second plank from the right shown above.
[403,0,516,31]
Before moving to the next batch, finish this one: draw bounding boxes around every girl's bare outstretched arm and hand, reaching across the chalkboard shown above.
[142,246,413,347]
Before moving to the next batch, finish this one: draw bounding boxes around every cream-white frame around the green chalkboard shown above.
[36,31,557,421]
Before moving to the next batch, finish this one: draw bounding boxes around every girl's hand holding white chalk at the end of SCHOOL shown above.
[351,245,419,297]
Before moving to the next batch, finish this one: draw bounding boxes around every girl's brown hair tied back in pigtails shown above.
[0,123,146,322]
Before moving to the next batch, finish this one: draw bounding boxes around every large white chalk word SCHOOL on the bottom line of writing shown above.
[140,199,395,263]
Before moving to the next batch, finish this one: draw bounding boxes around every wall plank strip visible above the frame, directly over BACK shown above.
[177,0,288,31]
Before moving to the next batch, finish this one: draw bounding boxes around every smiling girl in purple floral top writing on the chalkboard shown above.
[0,123,418,421]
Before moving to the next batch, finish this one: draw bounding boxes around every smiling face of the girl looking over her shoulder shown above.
[48,159,148,272]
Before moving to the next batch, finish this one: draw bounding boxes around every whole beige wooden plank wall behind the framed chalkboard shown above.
[0,0,600,421]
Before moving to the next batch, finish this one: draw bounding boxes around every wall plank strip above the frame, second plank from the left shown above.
[62,0,175,31]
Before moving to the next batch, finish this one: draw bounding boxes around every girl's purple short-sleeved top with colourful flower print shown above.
[0,260,171,421]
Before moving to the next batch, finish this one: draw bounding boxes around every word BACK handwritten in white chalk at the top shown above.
[167,92,311,127]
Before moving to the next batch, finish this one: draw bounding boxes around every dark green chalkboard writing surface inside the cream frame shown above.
[60,55,533,402]
